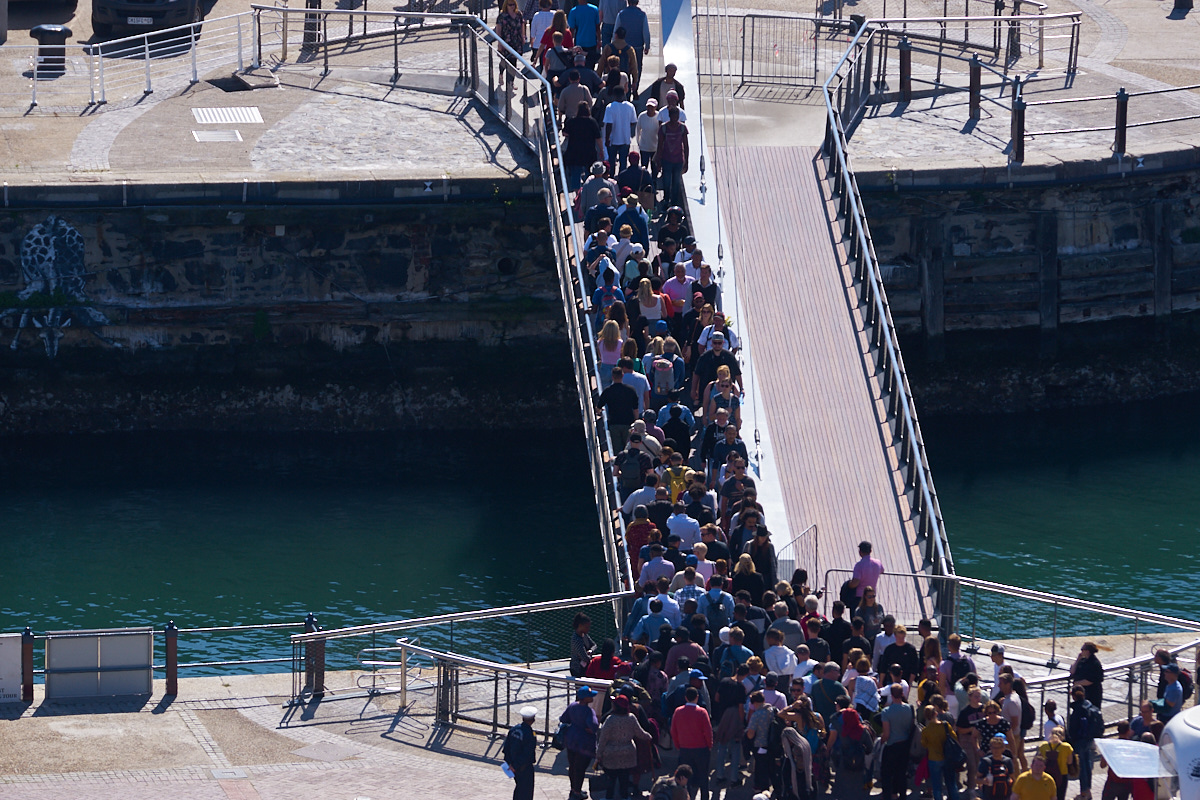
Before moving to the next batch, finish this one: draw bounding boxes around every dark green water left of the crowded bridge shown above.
[0,431,607,669]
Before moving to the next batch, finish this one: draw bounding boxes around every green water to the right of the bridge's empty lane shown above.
[922,396,1200,627]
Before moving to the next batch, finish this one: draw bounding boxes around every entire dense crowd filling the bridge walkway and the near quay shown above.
[482,7,1192,800]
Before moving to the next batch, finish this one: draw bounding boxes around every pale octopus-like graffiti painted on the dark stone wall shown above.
[0,215,108,359]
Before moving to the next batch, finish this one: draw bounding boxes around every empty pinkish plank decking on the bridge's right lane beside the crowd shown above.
[713,148,922,609]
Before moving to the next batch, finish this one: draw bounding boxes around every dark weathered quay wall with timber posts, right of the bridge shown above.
[864,170,1200,359]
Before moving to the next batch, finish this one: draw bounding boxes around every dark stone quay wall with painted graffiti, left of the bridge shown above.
[0,194,578,434]
